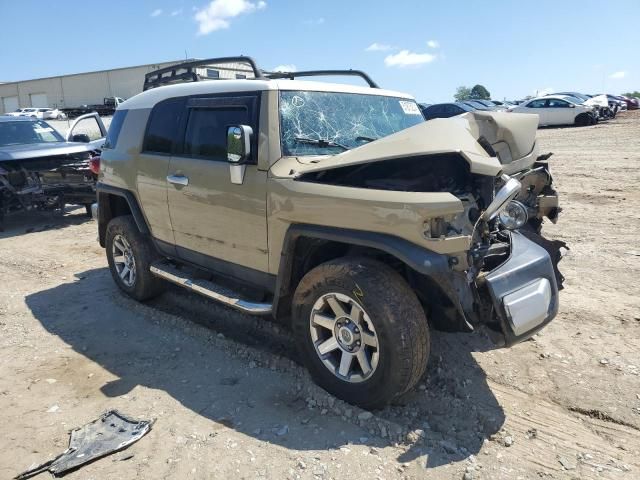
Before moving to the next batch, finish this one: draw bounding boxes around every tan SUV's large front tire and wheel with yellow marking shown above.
[292,257,429,409]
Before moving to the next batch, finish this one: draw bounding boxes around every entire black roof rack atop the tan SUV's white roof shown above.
[143,55,380,90]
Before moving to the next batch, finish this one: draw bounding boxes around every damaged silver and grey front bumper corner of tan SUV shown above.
[485,231,558,346]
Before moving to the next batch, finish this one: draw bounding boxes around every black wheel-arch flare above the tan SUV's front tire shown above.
[273,224,473,331]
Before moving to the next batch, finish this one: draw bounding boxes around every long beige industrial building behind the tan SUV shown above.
[0,60,255,114]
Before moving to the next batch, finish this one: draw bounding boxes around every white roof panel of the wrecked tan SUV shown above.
[118,79,413,110]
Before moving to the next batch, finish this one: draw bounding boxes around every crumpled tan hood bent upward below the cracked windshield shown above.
[271,112,538,177]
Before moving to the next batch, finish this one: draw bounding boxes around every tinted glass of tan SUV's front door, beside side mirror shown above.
[184,106,250,161]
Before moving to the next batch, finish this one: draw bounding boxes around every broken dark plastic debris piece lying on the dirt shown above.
[14,410,153,480]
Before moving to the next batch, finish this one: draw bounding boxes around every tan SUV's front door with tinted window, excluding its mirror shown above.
[167,93,268,283]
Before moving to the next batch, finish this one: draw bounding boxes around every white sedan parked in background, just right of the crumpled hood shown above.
[509,95,597,127]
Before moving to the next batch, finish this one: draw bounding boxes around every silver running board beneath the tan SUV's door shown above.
[149,261,272,315]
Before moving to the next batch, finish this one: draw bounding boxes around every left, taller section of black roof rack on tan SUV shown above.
[143,55,266,91]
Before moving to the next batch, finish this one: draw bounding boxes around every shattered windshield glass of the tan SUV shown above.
[280,91,424,156]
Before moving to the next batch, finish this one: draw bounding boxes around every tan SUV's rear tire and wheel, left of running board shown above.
[105,215,164,301]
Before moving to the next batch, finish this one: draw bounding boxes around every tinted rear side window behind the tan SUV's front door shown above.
[142,98,184,154]
